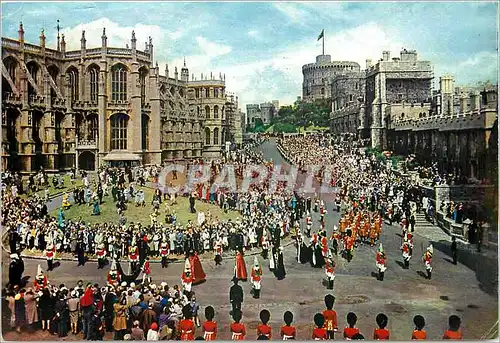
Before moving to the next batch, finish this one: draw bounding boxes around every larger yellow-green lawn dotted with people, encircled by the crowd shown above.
[50,188,239,225]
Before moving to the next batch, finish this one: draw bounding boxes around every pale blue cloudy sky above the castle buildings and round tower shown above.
[2,1,498,111]
